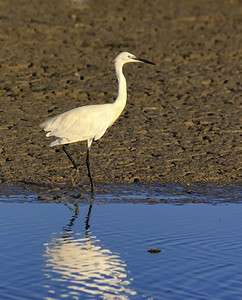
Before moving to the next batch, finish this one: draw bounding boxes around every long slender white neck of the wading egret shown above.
[114,62,127,113]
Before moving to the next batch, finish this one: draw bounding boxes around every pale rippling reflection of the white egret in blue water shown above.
[44,204,136,299]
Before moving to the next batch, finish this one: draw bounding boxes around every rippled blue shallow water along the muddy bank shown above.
[0,187,242,299]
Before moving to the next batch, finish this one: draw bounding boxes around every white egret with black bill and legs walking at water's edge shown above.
[40,52,154,192]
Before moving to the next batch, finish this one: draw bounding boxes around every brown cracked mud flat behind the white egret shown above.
[0,0,242,190]
